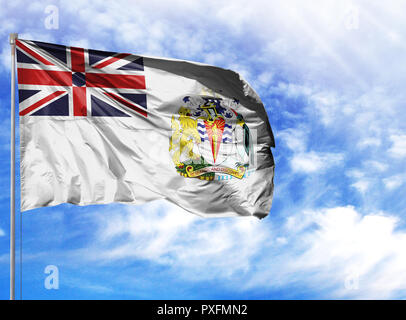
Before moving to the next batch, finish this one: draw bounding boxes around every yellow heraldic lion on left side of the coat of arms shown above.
[169,107,201,167]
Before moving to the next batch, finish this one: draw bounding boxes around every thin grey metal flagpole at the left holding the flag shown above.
[10,33,18,300]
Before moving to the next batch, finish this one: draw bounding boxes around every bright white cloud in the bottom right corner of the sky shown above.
[248,207,406,299]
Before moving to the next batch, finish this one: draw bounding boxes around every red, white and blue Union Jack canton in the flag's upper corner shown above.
[16,40,148,117]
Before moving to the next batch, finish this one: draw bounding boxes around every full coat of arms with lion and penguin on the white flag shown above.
[169,96,254,181]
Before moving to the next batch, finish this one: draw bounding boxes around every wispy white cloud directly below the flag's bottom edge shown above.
[86,202,270,278]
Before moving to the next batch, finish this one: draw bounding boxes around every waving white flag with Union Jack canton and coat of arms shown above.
[16,39,274,218]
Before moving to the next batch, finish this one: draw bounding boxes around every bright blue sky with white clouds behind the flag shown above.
[0,0,406,299]
